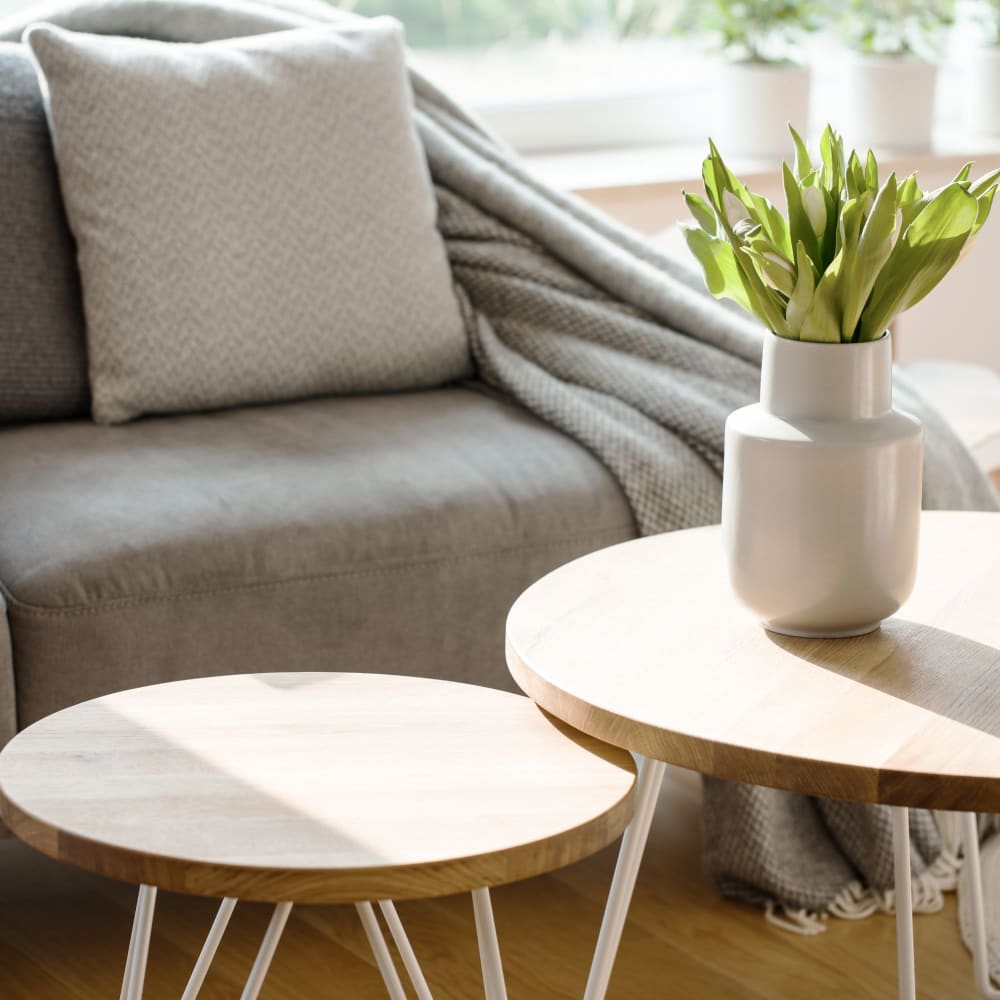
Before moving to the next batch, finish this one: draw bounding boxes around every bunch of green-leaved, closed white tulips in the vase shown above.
[684,125,1000,343]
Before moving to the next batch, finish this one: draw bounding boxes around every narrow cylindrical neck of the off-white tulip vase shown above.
[760,333,892,420]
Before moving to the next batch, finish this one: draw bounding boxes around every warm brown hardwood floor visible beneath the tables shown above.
[0,771,976,1000]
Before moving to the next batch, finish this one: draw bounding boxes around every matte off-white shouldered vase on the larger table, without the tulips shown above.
[722,334,923,637]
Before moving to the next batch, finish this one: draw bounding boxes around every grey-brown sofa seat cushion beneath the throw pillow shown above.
[0,388,634,726]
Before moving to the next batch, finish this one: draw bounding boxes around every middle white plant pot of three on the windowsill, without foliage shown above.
[841,53,937,150]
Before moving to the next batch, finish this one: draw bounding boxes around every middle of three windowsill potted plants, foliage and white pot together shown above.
[841,0,954,150]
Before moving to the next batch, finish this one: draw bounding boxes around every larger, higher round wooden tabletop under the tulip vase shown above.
[507,512,1000,812]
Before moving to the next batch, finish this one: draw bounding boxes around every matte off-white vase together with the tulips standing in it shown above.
[685,126,1000,636]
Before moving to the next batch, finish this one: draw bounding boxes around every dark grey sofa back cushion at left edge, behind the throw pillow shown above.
[0,42,90,422]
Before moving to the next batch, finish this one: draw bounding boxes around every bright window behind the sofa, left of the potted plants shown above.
[339,0,711,151]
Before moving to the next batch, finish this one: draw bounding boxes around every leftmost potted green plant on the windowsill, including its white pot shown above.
[677,0,820,158]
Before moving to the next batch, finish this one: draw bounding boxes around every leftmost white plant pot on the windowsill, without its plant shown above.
[715,63,810,160]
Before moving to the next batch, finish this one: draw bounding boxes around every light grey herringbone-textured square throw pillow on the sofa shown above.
[25,18,470,423]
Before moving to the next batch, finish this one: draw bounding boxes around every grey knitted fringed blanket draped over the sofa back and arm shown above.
[0,0,996,929]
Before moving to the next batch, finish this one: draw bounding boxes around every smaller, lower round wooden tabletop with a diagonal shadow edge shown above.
[0,673,635,903]
